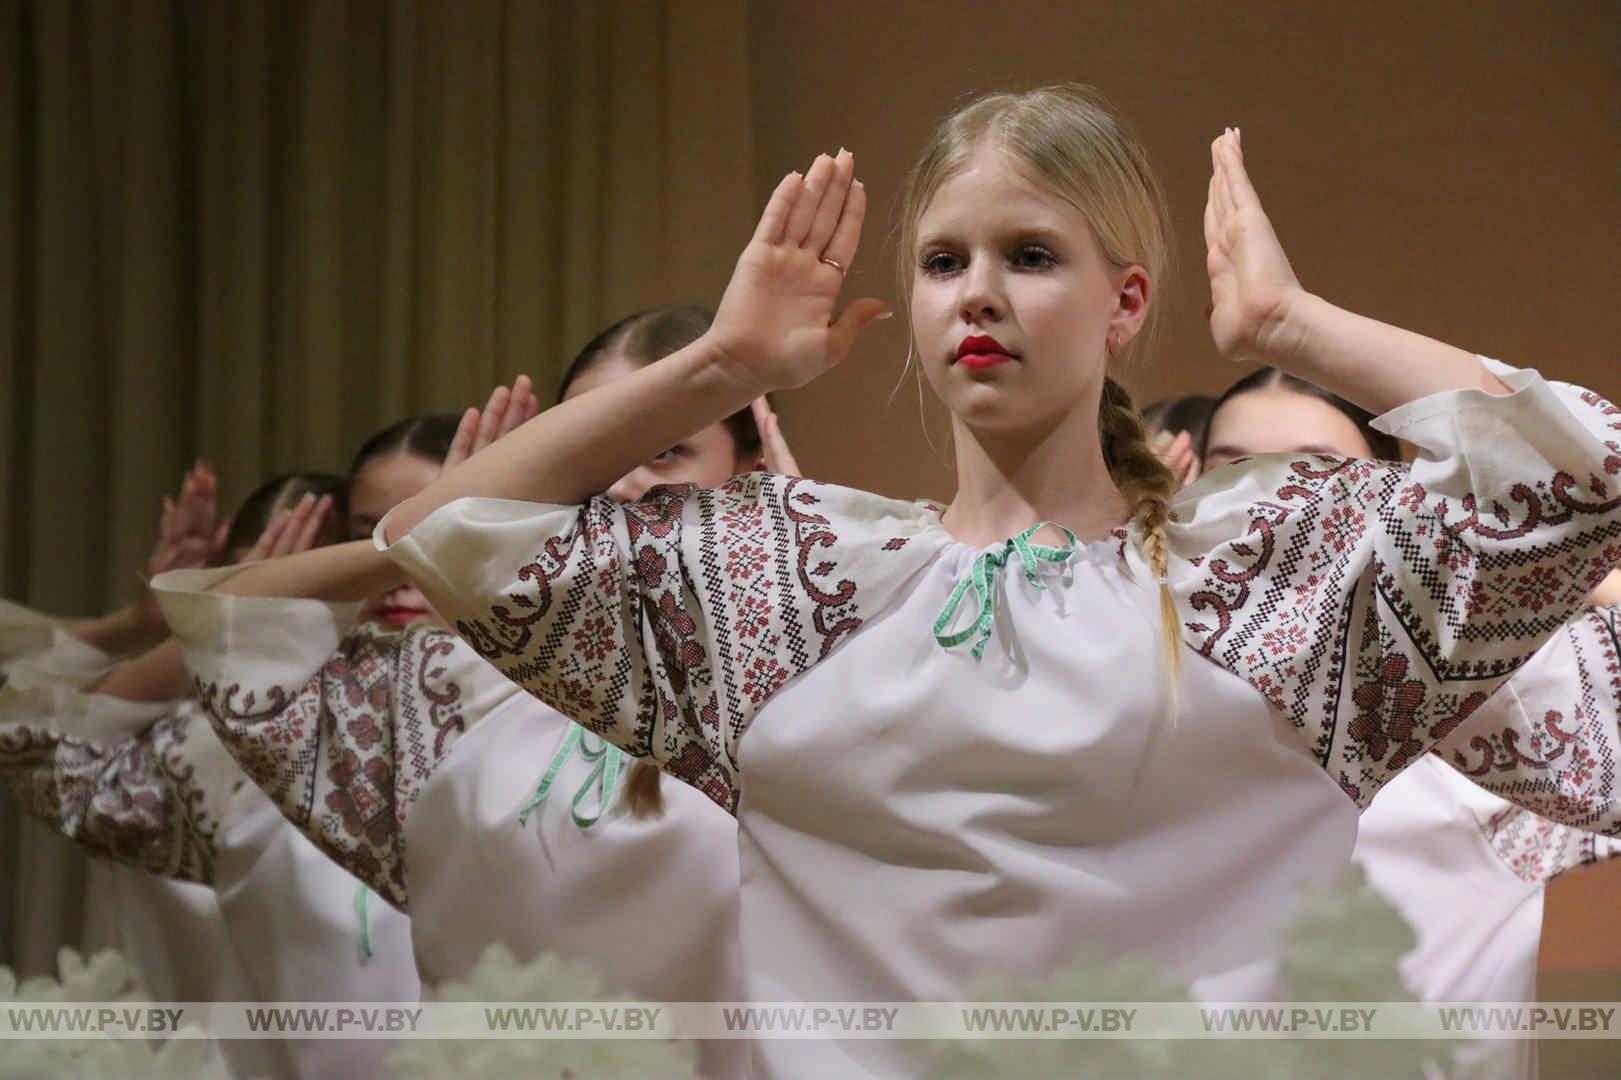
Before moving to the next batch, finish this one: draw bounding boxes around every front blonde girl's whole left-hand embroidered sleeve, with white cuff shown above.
[379,472,939,812]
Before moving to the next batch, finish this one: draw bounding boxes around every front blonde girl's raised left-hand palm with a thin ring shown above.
[708,151,888,392]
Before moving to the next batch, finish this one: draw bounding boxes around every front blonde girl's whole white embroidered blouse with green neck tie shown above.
[379,363,1621,1077]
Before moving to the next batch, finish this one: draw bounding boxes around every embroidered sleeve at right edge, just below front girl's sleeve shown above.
[1438,605,1621,835]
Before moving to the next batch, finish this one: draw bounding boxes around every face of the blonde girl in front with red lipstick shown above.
[911,146,1149,431]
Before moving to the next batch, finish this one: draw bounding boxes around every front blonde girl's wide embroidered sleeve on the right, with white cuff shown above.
[1169,361,1621,807]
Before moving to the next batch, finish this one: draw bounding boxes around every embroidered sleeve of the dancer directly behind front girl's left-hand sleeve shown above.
[154,571,514,910]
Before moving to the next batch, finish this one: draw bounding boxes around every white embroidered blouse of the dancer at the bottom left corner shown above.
[0,606,420,1078]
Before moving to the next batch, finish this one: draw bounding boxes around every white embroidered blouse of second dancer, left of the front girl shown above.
[156,571,747,1077]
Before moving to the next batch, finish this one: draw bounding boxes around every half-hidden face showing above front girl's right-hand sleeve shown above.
[1204,386,1373,469]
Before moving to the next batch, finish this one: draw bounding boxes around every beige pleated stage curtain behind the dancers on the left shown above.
[0,0,757,971]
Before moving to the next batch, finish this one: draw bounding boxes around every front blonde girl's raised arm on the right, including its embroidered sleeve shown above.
[1167,133,1621,820]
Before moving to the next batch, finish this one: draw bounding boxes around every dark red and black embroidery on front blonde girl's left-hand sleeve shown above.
[450,474,929,811]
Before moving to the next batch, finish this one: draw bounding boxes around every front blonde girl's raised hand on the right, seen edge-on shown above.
[1204,128,1303,358]
